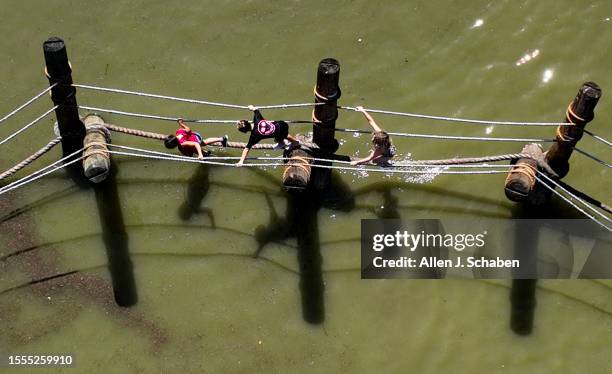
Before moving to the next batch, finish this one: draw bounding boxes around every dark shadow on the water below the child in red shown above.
[178,164,216,229]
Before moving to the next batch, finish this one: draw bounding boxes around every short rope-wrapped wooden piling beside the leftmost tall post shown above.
[83,114,111,183]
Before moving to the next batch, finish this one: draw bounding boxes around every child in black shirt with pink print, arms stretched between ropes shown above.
[236,105,298,166]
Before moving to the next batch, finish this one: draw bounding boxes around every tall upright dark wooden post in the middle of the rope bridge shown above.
[312,58,341,153]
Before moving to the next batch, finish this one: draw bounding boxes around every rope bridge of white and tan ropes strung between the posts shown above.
[0,83,612,231]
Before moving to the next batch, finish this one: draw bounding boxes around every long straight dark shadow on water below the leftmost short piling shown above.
[93,161,138,307]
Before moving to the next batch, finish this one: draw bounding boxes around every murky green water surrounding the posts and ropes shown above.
[0,0,612,373]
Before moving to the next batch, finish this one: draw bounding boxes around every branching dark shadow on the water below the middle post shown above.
[255,174,355,324]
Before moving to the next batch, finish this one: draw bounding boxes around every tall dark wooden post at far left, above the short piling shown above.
[43,37,85,156]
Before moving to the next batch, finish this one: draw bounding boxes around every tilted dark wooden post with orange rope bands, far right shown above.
[546,82,601,179]
